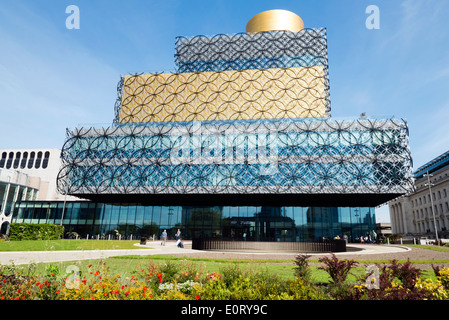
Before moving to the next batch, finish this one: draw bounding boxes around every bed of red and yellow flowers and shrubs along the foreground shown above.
[0,255,449,300]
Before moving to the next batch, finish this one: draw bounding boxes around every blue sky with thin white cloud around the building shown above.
[0,0,449,222]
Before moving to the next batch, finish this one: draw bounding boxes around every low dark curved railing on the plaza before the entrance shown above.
[192,238,346,253]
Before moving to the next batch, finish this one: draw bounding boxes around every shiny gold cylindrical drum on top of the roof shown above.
[246,9,304,33]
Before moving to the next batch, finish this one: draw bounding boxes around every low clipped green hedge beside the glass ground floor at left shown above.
[9,223,64,240]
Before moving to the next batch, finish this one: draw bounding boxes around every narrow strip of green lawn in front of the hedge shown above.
[0,240,149,252]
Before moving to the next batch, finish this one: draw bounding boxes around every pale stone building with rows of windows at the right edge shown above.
[388,151,449,238]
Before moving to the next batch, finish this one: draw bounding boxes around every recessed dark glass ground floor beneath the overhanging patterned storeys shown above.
[12,201,376,242]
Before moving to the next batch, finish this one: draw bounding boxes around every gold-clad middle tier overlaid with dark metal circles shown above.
[119,66,326,123]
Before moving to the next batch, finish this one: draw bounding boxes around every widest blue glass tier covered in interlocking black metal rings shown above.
[58,119,411,194]
